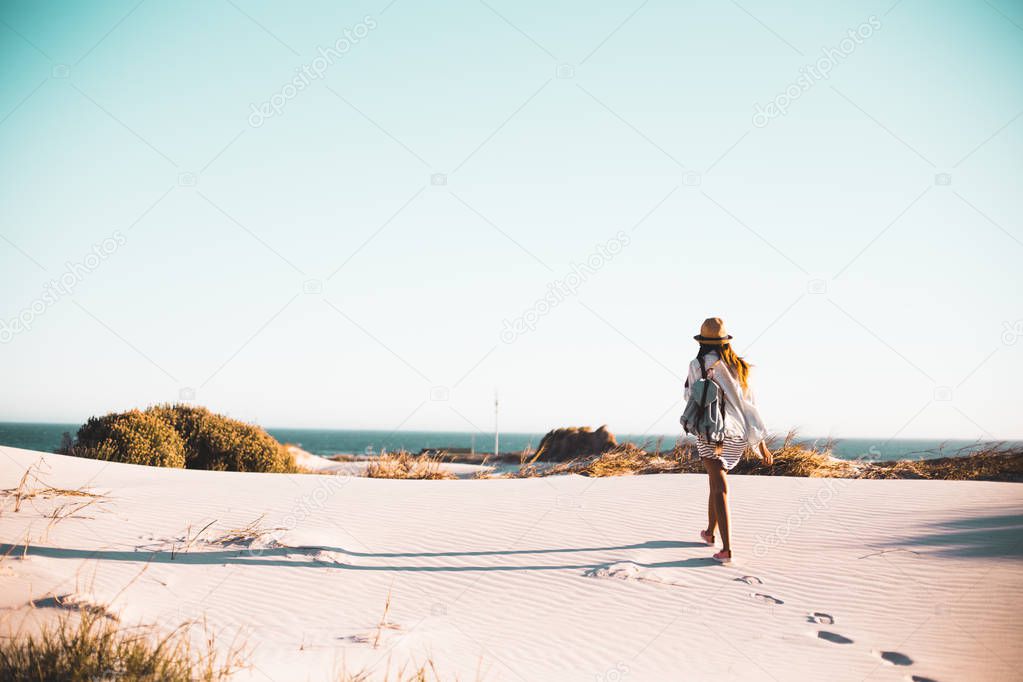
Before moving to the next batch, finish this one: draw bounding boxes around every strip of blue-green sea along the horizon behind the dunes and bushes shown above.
[0,422,1010,461]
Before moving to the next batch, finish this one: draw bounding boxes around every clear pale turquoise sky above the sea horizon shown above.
[0,0,1023,439]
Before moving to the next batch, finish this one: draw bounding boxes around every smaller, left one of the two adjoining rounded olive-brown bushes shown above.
[73,410,185,468]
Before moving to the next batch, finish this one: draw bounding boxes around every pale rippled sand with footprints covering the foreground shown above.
[0,448,1023,682]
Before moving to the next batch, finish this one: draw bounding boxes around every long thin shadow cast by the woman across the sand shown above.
[0,540,717,573]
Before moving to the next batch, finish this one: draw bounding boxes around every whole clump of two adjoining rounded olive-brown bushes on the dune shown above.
[69,405,299,473]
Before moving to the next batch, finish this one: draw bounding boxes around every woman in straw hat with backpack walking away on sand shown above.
[681,317,773,563]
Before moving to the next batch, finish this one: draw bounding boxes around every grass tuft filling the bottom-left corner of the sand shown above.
[0,609,241,682]
